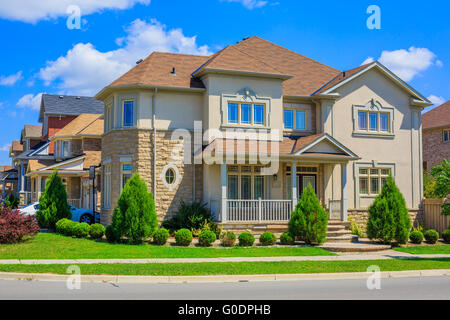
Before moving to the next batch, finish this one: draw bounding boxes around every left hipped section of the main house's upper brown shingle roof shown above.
[109,52,208,88]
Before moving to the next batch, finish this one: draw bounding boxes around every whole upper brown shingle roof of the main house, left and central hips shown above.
[101,37,340,96]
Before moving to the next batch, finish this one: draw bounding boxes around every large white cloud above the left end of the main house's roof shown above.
[38,19,211,95]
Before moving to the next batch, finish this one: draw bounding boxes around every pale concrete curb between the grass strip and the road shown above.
[0,269,450,283]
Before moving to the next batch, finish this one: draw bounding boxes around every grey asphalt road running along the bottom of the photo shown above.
[0,276,450,300]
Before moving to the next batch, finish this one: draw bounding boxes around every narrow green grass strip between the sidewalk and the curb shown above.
[0,258,450,276]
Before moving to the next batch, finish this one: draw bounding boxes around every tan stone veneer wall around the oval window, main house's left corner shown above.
[101,129,203,225]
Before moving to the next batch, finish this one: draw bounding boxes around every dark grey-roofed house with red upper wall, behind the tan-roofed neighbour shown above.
[11,94,103,205]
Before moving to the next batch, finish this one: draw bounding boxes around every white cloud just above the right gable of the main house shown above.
[366,47,443,81]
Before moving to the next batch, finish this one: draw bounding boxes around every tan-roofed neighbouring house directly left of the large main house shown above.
[26,114,104,209]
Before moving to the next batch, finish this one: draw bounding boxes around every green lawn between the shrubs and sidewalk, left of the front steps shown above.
[0,233,336,260]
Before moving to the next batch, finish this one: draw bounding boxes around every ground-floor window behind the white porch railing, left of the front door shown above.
[227,166,265,200]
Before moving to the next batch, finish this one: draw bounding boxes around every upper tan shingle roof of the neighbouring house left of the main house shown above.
[54,113,104,137]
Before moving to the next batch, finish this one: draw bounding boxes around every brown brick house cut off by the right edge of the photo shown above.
[422,101,450,171]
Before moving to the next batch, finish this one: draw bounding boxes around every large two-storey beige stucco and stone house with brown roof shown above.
[96,37,431,228]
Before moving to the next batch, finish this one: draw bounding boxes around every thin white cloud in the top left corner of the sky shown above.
[0,0,150,23]
